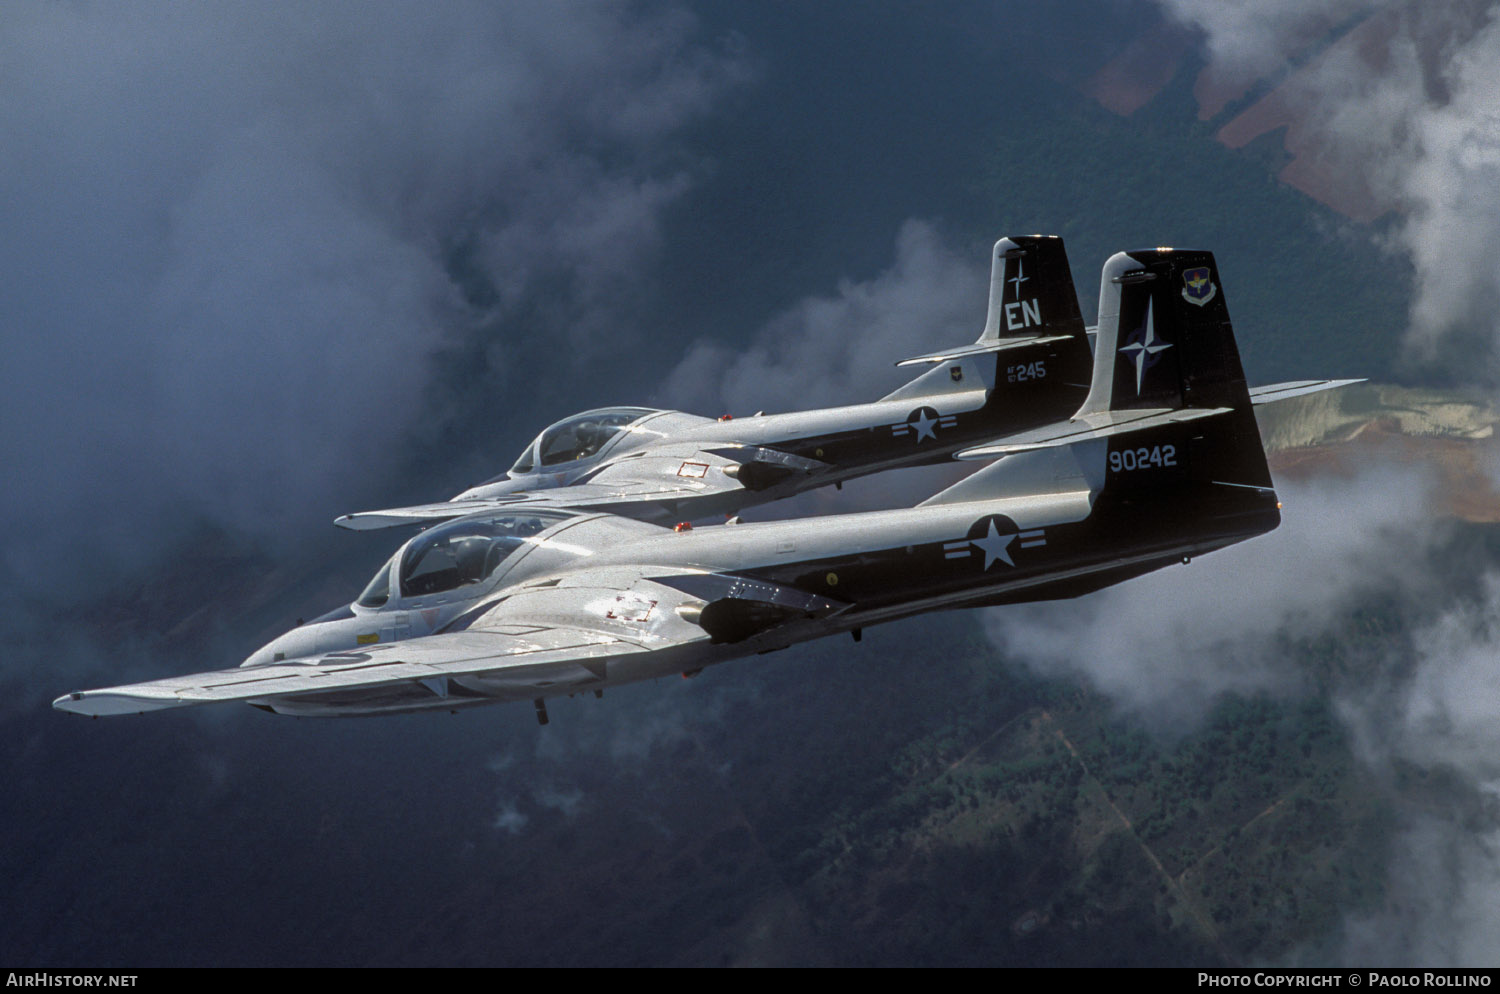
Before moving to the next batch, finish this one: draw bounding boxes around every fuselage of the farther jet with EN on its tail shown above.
[453,339,1091,523]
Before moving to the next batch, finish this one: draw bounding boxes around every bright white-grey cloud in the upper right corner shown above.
[1160,0,1500,374]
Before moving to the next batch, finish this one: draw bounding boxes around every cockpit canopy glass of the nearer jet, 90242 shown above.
[399,511,570,597]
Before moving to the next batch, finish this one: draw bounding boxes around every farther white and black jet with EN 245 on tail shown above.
[336,235,1358,531]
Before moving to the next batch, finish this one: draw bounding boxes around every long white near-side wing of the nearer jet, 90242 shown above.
[53,567,848,715]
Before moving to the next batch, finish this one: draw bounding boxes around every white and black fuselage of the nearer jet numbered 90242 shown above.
[246,458,1280,715]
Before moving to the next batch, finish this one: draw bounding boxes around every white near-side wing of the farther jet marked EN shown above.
[335,444,830,531]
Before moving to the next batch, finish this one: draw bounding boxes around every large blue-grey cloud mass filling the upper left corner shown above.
[0,3,743,585]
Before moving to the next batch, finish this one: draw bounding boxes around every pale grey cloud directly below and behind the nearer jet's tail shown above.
[984,466,1443,726]
